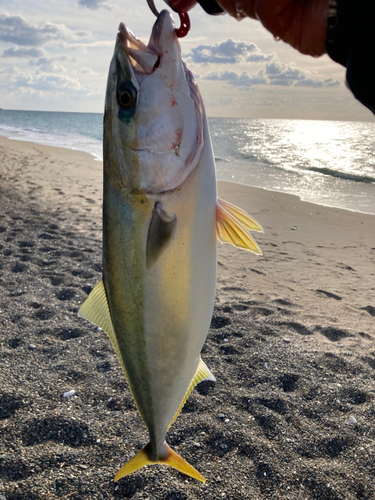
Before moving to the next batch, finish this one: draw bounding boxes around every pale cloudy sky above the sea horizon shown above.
[0,0,375,121]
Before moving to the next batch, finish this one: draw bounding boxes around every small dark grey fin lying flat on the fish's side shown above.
[146,201,177,269]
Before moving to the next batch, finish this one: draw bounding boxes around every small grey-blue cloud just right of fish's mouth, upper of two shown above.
[188,38,274,64]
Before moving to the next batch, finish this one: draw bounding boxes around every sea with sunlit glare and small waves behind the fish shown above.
[0,110,375,214]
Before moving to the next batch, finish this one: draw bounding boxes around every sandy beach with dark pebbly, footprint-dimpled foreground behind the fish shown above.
[0,137,375,500]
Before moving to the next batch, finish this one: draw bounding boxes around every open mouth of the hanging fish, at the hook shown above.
[117,10,174,80]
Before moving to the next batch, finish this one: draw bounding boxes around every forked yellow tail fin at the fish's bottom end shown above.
[115,445,206,483]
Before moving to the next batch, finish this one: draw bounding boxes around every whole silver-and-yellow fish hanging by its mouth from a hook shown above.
[79,10,262,482]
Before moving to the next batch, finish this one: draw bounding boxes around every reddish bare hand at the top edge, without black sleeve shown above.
[217,0,329,57]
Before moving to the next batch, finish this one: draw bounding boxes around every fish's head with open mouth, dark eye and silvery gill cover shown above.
[104,10,204,194]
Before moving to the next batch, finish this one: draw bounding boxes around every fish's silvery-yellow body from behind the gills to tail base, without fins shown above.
[103,109,216,456]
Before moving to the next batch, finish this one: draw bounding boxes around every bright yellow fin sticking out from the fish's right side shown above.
[216,199,263,255]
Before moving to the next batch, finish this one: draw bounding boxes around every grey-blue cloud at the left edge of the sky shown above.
[0,14,89,47]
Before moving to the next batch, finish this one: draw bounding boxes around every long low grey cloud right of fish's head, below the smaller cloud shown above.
[203,61,341,89]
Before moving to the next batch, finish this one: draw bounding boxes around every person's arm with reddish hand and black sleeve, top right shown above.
[204,0,375,113]
